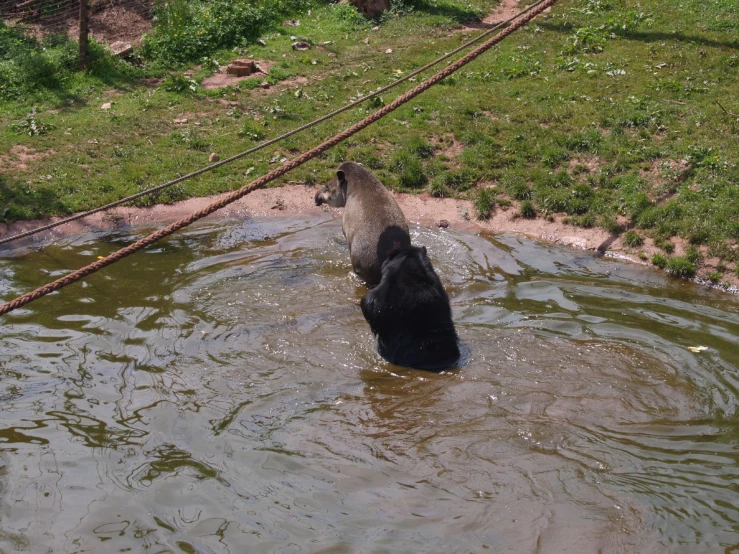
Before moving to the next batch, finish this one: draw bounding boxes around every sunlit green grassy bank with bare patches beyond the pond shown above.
[0,0,739,278]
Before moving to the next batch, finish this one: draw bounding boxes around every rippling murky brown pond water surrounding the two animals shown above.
[0,216,739,554]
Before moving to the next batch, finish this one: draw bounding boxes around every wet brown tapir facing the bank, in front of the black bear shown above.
[315,162,411,287]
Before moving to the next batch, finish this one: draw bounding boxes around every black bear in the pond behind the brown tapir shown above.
[361,246,460,371]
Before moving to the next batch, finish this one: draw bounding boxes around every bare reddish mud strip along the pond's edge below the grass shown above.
[0,184,739,294]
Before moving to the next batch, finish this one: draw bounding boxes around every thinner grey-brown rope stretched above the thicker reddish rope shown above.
[0,0,543,244]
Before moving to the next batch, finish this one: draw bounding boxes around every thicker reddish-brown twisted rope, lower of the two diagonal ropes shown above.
[0,0,557,315]
